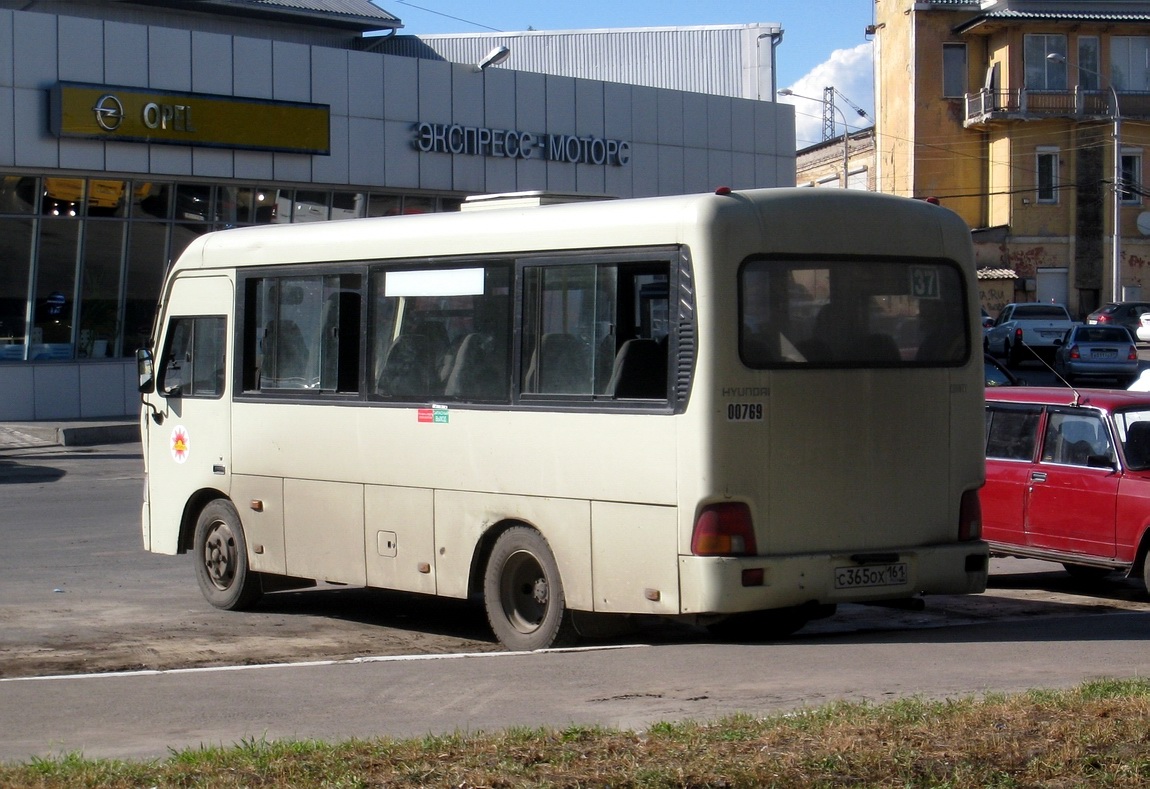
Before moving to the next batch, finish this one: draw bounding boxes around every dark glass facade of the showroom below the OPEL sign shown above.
[0,174,461,362]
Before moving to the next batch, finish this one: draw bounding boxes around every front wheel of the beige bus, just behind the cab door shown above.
[193,499,263,611]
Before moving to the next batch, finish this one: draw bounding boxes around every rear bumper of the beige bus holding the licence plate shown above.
[679,541,989,614]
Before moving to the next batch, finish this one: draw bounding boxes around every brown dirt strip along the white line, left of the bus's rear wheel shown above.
[0,589,503,677]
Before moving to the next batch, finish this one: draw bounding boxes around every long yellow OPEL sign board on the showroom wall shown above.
[49,82,331,155]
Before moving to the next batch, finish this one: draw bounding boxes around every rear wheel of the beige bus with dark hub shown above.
[483,526,577,652]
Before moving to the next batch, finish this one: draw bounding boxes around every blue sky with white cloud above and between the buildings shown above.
[373,0,875,148]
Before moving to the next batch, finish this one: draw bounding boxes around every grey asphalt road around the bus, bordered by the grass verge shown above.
[0,446,1150,760]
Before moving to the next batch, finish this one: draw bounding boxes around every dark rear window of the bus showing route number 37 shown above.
[739,260,971,368]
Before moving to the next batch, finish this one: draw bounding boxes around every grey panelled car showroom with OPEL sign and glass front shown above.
[0,0,795,421]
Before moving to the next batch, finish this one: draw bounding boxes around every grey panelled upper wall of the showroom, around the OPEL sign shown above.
[0,12,794,202]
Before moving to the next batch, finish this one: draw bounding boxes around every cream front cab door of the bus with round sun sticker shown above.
[144,276,233,553]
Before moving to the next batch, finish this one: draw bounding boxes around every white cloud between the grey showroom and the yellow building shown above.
[779,41,874,148]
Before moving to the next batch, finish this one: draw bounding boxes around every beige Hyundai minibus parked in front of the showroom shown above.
[139,189,987,650]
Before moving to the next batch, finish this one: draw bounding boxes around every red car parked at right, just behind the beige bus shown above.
[981,386,1150,587]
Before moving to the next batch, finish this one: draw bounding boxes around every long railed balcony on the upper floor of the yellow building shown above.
[963,87,1150,129]
